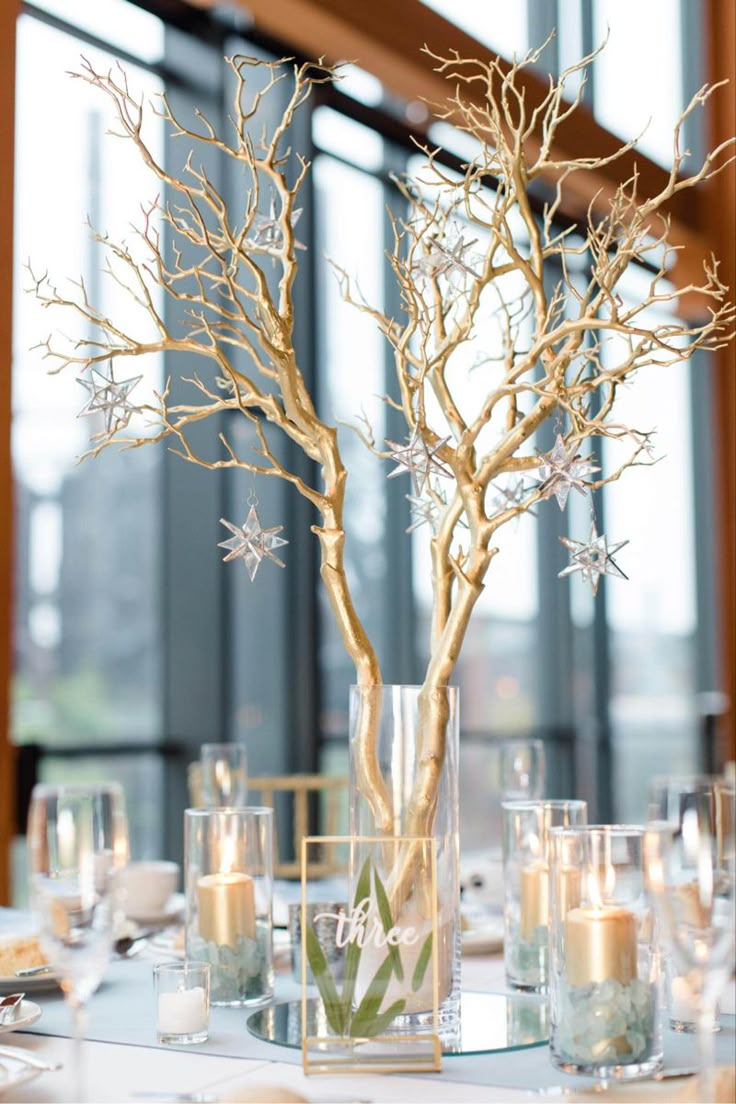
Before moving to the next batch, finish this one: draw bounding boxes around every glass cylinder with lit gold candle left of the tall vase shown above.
[184,806,274,1007]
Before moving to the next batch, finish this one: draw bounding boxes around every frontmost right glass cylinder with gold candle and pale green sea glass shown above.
[550,825,662,1080]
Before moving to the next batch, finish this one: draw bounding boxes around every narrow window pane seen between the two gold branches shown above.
[314,146,390,736]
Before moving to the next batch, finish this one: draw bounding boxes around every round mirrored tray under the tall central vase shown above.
[247,992,550,1057]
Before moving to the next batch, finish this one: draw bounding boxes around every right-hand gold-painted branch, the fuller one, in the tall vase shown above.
[340,40,735,904]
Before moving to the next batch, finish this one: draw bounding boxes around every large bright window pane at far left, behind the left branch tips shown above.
[11,3,163,874]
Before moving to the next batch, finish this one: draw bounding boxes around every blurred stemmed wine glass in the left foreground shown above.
[28,783,128,1101]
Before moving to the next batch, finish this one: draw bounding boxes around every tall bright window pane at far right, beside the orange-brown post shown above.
[604,267,705,820]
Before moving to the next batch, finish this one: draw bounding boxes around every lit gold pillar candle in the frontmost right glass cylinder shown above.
[565,907,637,986]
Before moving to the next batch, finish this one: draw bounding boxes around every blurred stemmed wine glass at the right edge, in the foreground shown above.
[644,776,736,1100]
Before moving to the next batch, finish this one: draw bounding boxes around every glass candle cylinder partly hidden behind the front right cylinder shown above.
[502,800,587,992]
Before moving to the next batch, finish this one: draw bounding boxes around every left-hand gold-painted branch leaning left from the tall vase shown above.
[31,51,391,831]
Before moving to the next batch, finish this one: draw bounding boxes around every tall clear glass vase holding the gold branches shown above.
[350,684,460,1036]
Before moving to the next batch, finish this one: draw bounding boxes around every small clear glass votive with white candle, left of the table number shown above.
[153,962,210,1047]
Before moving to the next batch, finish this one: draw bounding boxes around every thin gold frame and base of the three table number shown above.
[300,836,442,1074]
